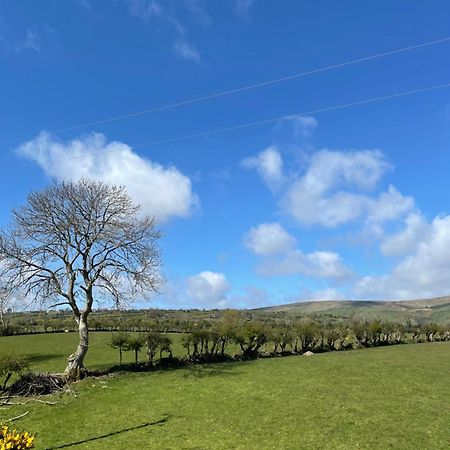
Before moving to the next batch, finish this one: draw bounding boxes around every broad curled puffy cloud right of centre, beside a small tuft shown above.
[282,149,414,227]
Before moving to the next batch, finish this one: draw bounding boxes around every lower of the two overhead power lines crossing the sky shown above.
[58,83,450,161]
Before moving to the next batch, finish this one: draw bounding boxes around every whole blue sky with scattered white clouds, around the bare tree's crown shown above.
[0,0,450,308]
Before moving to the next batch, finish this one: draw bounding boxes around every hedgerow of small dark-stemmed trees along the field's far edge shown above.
[110,314,450,366]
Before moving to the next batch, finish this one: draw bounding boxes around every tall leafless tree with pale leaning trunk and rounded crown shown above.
[0,180,160,377]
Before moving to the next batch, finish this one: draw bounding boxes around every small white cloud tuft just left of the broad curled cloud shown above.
[241,145,284,189]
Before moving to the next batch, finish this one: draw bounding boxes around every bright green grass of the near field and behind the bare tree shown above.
[0,333,450,450]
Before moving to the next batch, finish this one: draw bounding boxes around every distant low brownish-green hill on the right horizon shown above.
[251,296,450,323]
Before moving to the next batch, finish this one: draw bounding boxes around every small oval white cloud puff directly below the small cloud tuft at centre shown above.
[244,223,295,256]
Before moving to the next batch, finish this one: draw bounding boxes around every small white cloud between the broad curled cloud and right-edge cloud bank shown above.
[381,213,431,256]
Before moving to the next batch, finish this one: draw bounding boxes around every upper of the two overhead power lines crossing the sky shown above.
[0,36,450,145]
